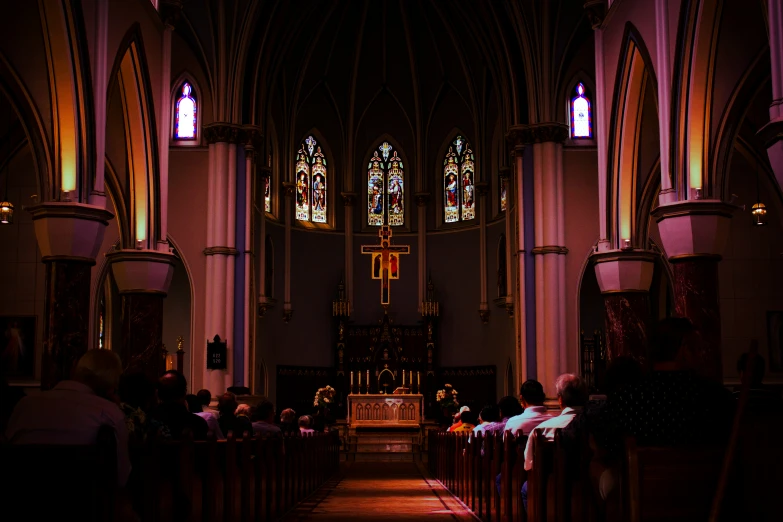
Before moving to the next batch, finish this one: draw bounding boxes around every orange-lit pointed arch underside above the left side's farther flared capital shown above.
[109,24,161,248]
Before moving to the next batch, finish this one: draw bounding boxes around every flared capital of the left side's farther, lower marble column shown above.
[106,250,176,296]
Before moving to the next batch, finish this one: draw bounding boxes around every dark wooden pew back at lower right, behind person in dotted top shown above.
[621,438,725,522]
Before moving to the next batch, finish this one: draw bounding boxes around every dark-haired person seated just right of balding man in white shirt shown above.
[119,369,171,443]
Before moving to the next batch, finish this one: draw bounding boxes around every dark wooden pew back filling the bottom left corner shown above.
[0,427,117,522]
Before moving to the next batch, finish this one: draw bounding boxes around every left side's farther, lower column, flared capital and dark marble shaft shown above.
[106,250,174,379]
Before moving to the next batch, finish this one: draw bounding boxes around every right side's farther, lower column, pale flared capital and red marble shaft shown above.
[591,250,657,365]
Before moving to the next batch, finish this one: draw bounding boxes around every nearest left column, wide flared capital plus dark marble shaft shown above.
[27,202,114,389]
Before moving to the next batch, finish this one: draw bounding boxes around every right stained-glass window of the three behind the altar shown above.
[443,136,476,223]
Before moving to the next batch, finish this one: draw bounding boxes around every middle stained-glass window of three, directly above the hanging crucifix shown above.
[367,141,405,227]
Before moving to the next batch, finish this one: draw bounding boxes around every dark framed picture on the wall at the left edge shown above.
[0,315,35,381]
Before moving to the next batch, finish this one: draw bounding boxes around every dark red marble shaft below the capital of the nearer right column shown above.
[672,256,723,382]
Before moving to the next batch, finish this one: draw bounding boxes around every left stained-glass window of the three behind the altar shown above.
[296,136,328,223]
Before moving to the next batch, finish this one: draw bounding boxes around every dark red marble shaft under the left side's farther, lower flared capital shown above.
[120,293,165,379]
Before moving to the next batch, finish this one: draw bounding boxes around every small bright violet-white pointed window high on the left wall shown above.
[169,72,203,147]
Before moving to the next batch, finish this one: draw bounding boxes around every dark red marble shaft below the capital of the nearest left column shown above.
[41,259,95,390]
